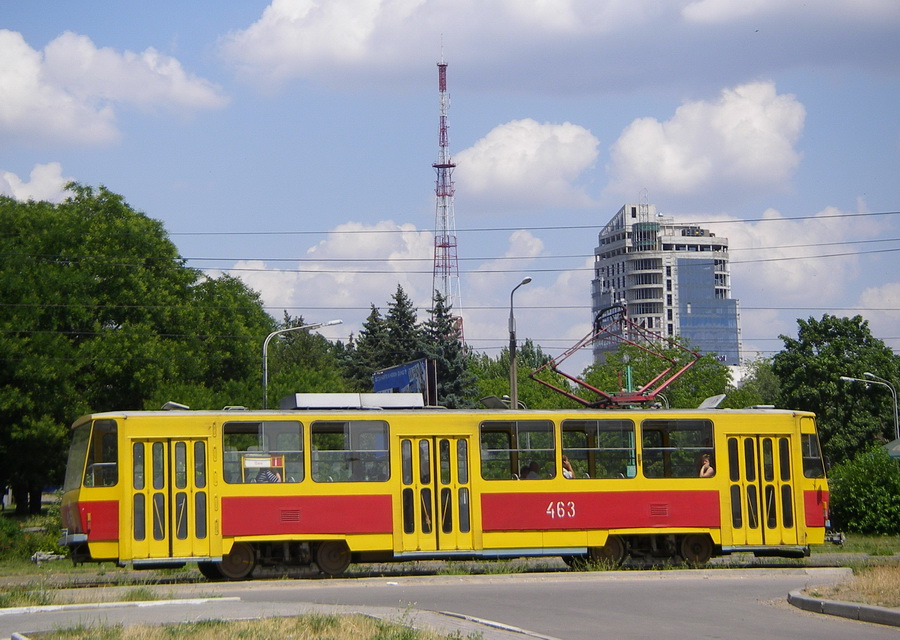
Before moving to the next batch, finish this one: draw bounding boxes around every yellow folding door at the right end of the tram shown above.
[726,435,798,546]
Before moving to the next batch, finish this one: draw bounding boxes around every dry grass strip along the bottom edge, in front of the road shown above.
[31,614,481,640]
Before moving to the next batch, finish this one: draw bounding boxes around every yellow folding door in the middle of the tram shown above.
[398,436,473,553]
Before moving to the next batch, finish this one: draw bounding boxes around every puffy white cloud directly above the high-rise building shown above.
[609,82,806,198]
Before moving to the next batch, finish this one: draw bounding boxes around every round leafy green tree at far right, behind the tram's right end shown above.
[772,314,898,462]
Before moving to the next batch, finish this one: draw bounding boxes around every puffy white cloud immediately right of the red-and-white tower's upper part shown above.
[455,118,600,210]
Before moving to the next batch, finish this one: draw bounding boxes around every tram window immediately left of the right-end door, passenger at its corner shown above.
[641,420,715,478]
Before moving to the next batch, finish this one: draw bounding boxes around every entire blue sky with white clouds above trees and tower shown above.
[0,0,900,373]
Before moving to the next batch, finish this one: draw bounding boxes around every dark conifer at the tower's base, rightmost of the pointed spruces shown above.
[422,291,475,409]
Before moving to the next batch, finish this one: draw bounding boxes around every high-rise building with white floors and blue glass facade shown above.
[591,204,741,365]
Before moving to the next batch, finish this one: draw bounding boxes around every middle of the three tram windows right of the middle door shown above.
[562,420,637,478]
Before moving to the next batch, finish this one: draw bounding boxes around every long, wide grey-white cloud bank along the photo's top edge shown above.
[221,0,900,93]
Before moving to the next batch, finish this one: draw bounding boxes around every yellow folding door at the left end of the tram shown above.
[130,438,209,561]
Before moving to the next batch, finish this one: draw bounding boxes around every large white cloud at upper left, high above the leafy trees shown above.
[0,30,226,144]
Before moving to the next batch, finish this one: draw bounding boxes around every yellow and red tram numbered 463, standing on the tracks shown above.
[61,394,828,580]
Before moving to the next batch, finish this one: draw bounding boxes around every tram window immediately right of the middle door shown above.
[481,420,556,480]
